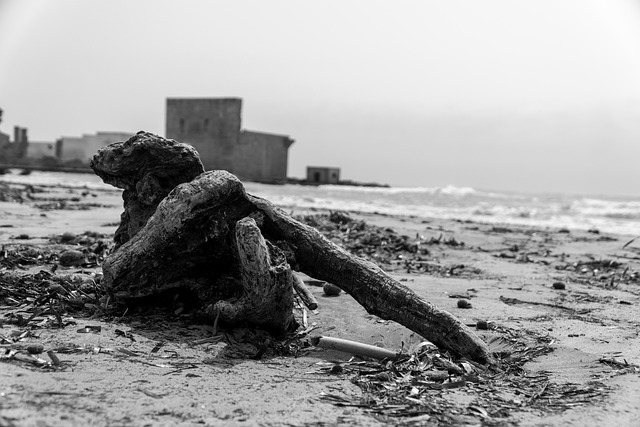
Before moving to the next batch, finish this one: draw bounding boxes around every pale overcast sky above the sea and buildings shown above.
[0,0,640,196]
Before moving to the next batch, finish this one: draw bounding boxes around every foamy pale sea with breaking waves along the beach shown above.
[0,170,640,237]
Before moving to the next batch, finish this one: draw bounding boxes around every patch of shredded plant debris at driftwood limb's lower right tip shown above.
[319,327,608,425]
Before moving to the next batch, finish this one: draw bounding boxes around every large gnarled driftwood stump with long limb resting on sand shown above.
[92,133,492,363]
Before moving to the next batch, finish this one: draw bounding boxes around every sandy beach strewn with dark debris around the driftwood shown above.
[0,178,640,427]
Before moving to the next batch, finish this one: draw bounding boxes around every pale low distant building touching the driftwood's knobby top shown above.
[55,132,133,166]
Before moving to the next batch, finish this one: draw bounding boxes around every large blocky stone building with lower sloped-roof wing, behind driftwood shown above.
[165,98,293,183]
